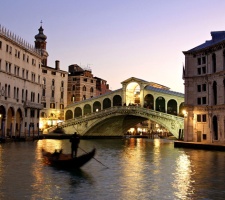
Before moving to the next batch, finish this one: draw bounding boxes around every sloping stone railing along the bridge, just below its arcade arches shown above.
[57,106,183,128]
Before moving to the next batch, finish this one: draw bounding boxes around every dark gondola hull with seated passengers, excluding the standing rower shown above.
[42,148,96,169]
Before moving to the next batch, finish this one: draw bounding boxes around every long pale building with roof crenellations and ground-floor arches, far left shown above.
[0,26,42,138]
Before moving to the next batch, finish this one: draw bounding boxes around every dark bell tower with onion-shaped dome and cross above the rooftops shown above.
[34,21,48,66]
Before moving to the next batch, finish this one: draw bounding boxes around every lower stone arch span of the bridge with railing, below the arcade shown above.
[58,106,184,138]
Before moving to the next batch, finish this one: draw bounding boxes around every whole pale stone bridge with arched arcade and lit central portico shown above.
[58,77,184,138]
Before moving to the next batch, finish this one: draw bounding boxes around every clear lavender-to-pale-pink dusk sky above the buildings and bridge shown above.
[0,0,225,93]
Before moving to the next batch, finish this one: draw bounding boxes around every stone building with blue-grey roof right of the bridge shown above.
[183,31,225,143]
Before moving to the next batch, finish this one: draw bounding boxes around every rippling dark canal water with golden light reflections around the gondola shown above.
[0,138,225,200]
